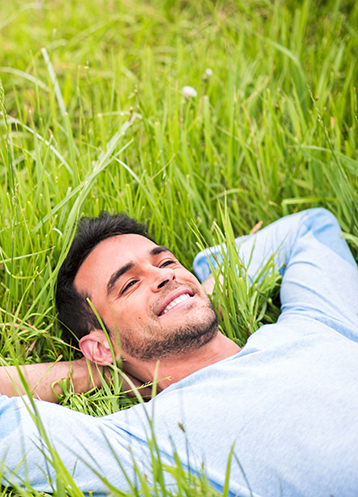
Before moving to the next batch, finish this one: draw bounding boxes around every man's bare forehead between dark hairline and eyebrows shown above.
[74,235,157,293]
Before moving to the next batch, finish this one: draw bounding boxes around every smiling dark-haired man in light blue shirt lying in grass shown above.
[0,209,358,497]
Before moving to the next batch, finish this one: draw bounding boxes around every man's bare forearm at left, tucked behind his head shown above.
[0,358,108,402]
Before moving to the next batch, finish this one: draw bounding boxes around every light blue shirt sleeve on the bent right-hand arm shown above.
[193,208,358,341]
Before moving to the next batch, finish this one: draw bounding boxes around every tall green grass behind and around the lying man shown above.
[0,0,358,495]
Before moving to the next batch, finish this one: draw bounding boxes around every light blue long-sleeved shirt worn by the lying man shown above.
[0,209,358,497]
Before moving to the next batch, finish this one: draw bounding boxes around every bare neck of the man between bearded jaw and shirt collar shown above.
[125,331,241,391]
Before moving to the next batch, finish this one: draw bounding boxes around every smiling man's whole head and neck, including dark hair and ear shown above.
[57,213,240,389]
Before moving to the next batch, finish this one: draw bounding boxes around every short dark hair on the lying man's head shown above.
[56,211,155,342]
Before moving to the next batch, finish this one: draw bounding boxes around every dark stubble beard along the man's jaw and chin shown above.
[120,299,219,361]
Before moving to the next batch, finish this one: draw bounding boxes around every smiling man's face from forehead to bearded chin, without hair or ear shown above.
[75,235,218,360]
